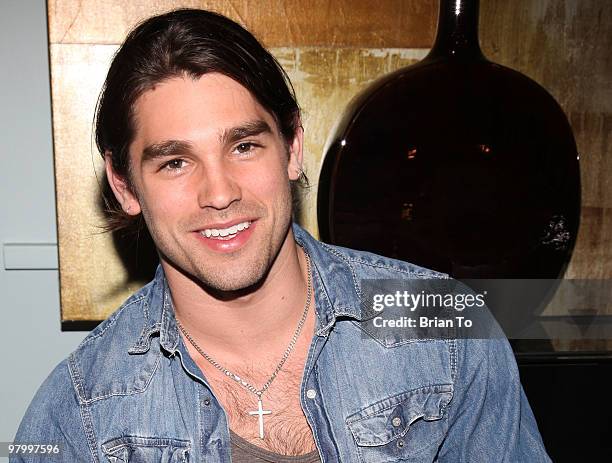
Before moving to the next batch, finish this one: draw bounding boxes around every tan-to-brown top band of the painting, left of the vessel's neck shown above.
[49,0,437,48]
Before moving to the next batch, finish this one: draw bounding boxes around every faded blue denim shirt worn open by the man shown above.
[10,224,550,463]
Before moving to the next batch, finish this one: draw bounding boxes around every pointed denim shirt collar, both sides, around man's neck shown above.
[129,223,363,354]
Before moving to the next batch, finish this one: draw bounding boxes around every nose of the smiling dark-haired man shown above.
[198,163,242,210]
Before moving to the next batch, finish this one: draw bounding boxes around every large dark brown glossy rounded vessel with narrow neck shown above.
[317,0,580,278]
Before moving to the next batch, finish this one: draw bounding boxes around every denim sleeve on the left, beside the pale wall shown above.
[9,361,93,463]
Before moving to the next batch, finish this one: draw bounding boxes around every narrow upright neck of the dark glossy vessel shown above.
[426,0,484,59]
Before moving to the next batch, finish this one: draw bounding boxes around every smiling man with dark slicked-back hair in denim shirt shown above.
[13,10,549,462]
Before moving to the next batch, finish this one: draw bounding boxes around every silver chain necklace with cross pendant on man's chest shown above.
[176,253,312,439]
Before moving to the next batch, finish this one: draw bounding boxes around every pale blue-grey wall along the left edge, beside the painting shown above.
[0,0,86,456]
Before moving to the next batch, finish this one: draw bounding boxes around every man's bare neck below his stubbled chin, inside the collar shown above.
[162,230,314,362]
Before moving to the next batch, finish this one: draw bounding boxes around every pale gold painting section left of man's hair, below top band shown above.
[50,45,139,320]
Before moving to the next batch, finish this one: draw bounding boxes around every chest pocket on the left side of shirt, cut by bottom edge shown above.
[102,436,191,463]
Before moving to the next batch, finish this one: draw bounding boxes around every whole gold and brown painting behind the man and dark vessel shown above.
[48,0,612,338]
